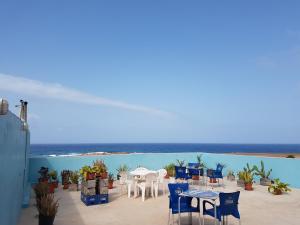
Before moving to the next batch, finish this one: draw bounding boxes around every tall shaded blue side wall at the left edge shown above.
[0,112,30,225]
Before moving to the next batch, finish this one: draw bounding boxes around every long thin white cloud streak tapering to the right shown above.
[0,73,172,116]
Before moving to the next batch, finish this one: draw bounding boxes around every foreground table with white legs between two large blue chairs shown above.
[178,190,219,225]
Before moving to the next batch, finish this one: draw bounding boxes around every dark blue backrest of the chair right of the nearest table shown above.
[219,191,240,218]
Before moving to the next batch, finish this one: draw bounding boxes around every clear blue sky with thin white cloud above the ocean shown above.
[0,1,300,143]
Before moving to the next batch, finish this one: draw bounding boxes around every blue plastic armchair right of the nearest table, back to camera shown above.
[202,191,241,225]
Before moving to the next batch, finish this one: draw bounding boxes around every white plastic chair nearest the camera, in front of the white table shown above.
[135,173,158,202]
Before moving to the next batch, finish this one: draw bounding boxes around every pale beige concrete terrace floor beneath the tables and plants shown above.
[19,179,300,225]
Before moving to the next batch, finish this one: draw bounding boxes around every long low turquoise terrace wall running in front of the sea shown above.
[30,153,300,188]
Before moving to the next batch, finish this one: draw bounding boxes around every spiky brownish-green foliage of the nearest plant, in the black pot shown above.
[37,194,59,217]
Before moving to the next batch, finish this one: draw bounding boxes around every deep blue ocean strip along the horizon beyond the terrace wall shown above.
[30,143,300,157]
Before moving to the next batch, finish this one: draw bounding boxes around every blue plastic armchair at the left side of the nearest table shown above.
[168,183,200,225]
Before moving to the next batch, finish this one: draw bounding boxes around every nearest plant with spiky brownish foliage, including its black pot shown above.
[37,194,58,225]
